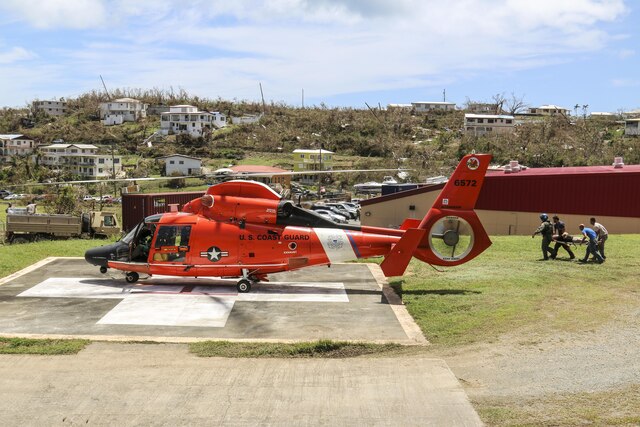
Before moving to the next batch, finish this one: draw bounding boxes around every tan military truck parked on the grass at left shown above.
[6,209,121,243]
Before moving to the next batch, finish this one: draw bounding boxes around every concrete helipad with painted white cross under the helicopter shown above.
[0,258,425,344]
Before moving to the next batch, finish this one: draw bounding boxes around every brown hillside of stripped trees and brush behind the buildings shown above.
[0,90,640,188]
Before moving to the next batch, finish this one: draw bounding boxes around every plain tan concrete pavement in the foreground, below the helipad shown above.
[0,343,482,426]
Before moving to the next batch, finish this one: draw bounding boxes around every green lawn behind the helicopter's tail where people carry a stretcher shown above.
[391,235,640,347]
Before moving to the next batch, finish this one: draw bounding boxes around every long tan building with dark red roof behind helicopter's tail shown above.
[360,158,640,236]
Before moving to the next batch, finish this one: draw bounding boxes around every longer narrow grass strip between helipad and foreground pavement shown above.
[189,340,403,358]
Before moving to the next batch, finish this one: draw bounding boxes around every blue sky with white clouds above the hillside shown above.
[0,0,640,113]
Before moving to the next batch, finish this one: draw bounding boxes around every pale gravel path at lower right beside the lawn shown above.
[438,306,640,425]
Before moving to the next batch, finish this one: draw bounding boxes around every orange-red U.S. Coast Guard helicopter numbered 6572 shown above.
[85,154,491,293]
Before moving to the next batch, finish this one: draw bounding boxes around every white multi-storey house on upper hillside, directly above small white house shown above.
[160,105,227,137]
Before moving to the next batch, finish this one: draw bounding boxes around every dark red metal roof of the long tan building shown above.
[360,165,640,217]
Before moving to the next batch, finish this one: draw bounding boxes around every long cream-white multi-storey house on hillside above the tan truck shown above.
[39,144,122,179]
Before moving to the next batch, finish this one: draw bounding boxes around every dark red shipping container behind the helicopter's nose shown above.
[122,191,205,231]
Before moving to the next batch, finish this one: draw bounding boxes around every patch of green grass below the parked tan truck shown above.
[0,239,102,278]
